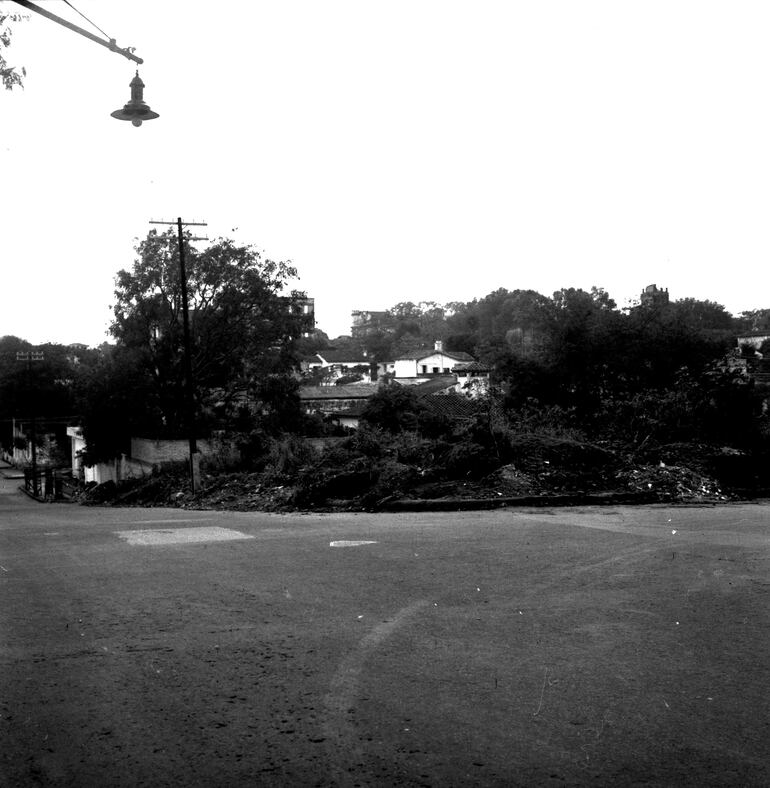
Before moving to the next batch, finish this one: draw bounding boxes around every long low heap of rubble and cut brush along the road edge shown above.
[81,436,730,512]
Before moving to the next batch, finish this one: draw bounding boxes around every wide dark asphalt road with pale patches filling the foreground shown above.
[0,481,770,786]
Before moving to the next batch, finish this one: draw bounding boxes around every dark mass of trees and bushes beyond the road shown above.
[0,231,770,510]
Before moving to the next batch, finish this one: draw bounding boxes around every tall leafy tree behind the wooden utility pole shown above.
[110,230,306,435]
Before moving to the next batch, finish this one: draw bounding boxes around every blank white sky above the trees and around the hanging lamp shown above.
[0,0,770,345]
